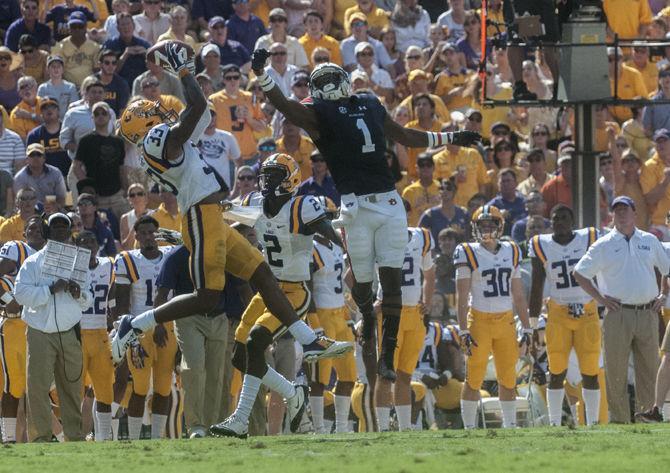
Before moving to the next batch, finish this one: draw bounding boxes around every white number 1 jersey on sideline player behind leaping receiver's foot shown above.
[114,246,172,315]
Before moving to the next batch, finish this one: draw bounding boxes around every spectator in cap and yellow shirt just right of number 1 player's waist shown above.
[402,153,440,227]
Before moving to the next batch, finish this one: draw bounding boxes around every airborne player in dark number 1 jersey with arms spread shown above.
[251,49,480,381]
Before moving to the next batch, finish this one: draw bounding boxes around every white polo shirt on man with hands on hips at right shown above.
[575,228,670,305]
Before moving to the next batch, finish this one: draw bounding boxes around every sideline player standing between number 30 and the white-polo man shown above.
[528,204,601,425]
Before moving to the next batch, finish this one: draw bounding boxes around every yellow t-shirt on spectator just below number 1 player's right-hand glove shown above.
[433,147,490,207]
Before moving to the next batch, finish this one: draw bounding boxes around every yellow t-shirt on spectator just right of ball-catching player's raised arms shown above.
[209,89,263,159]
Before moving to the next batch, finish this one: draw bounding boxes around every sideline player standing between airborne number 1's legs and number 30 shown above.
[375,227,435,432]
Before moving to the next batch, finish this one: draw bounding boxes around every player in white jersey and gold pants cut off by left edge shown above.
[0,216,47,443]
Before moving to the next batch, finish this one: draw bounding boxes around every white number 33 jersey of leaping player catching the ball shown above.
[140,111,227,209]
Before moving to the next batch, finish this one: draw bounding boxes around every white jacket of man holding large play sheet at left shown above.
[14,247,93,333]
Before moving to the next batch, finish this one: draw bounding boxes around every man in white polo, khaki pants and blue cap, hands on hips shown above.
[574,196,670,423]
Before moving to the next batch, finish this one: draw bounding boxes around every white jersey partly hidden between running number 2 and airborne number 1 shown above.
[312,241,344,309]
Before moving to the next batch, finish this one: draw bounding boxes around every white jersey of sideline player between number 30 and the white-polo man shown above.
[528,227,598,305]
